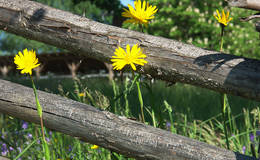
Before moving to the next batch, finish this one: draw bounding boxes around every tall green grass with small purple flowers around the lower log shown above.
[0,78,260,160]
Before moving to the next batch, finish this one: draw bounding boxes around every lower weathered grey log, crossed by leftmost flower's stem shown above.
[0,80,254,160]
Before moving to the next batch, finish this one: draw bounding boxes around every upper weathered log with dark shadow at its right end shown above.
[0,0,260,101]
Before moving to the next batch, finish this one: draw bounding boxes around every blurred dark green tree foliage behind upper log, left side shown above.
[0,0,122,55]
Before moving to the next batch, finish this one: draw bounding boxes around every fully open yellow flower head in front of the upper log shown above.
[111,44,147,70]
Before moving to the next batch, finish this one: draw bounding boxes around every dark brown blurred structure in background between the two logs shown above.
[0,53,107,74]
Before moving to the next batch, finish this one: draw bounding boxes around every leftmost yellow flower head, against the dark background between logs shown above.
[14,48,40,75]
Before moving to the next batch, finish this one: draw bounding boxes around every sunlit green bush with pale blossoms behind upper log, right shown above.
[123,0,260,58]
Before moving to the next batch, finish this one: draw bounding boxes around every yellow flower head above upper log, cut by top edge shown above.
[122,0,158,25]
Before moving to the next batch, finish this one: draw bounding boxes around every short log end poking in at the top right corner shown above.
[227,0,260,11]
